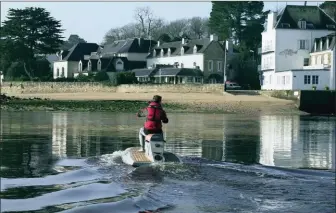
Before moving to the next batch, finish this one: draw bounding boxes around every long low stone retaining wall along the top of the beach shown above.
[1,82,223,93]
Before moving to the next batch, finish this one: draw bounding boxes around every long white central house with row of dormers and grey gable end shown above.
[147,35,233,83]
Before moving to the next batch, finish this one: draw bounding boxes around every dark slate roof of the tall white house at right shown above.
[275,5,336,30]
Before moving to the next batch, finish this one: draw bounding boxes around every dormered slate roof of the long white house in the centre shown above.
[147,38,211,58]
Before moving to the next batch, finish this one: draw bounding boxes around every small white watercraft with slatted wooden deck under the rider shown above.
[122,128,181,167]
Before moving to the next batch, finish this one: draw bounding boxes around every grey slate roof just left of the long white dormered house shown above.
[101,38,156,55]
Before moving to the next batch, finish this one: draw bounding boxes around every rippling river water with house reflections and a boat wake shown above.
[0,112,336,213]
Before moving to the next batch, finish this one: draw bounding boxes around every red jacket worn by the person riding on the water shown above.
[138,102,169,130]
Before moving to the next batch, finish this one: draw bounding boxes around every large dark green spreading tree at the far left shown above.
[1,7,63,80]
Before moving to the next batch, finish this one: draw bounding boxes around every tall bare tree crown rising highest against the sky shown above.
[134,7,164,38]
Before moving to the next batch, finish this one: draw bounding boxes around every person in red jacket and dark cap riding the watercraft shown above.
[137,95,169,151]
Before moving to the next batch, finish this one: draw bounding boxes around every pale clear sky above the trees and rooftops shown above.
[1,1,322,43]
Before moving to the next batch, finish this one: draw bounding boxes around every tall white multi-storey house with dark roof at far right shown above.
[259,5,336,90]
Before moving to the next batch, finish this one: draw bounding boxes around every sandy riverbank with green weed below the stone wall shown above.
[1,92,303,114]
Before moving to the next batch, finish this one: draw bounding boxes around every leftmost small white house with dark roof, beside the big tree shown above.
[53,43,100,79]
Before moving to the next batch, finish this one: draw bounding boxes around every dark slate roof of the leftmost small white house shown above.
[62,43,99,61]
